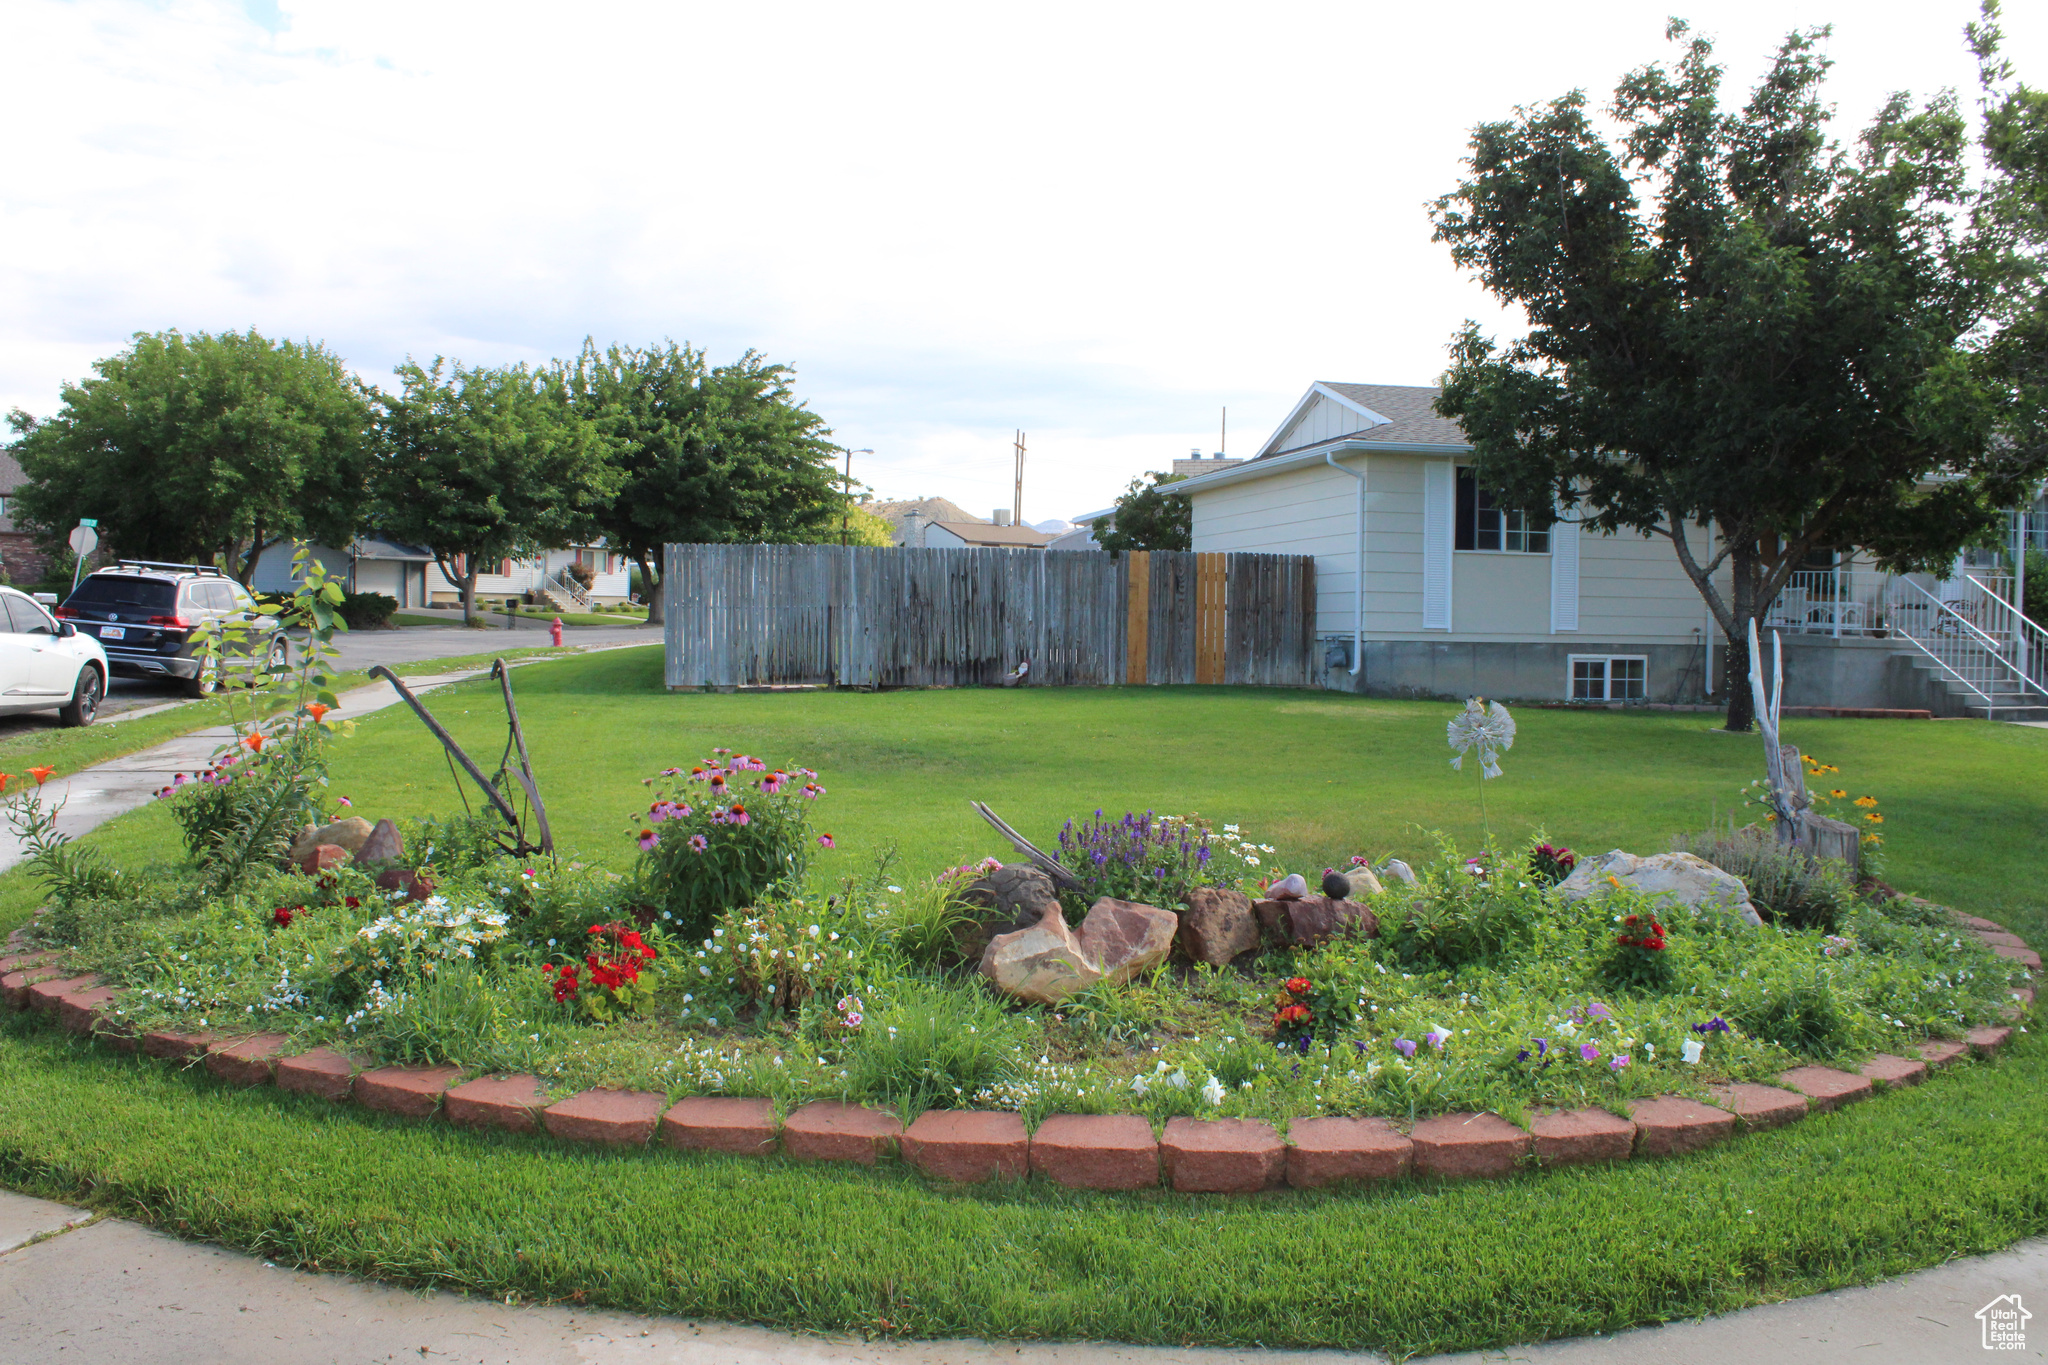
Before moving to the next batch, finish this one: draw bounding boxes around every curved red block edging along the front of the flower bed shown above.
[0,917,2034,1193]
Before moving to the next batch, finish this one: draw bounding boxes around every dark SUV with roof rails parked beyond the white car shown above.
[57,559,285,696]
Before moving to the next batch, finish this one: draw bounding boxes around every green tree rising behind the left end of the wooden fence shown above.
[563,340,848,622]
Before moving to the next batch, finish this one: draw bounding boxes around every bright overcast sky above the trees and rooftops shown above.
[0,0,2048,522]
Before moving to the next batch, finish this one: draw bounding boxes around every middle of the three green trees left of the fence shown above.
[375,356,621,620]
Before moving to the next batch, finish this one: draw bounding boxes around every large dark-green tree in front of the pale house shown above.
[1434,4,2048,731]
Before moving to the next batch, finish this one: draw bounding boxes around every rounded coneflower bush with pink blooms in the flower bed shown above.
[631,749,831,937]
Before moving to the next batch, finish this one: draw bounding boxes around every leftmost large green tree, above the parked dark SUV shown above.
[10,332,371,585]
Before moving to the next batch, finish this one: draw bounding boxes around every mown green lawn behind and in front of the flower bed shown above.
[0,649,2048,1353]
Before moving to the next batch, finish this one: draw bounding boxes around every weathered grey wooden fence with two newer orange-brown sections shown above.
[662,544,1315,688]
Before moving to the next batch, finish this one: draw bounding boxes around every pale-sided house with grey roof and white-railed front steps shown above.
[1171,383,2048,714]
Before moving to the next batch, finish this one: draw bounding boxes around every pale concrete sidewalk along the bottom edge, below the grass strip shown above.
[0,1193,2048,1365]
